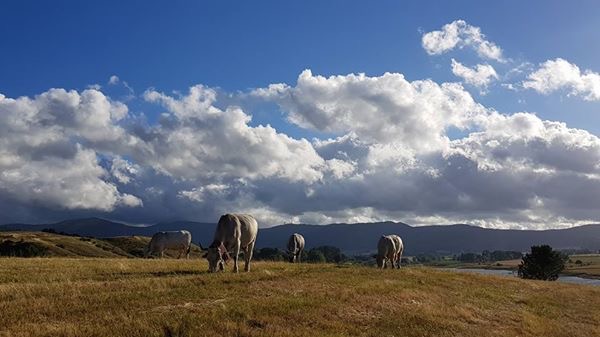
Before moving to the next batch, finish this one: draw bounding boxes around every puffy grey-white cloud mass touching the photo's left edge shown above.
[0,89,141,211]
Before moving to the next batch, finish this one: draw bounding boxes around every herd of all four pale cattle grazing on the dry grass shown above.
[144,214,404,273]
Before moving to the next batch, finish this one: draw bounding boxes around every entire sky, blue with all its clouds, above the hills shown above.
[0,1,600,229]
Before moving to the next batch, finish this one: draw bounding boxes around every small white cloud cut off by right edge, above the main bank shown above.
[523,58,600,101]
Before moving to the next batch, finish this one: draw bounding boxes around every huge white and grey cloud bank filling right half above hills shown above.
[244,72,600,228]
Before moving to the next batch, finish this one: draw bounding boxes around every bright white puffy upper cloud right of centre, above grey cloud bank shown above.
[254,70,486,152]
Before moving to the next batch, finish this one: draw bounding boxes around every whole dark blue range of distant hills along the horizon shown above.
[0,218,600,255]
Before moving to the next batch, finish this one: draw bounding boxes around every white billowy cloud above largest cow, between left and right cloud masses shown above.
[142,86,325,183]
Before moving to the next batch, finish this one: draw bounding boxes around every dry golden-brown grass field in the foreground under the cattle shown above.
[0,258,600,337]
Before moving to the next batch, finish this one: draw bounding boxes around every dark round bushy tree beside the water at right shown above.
[518,245,568,281]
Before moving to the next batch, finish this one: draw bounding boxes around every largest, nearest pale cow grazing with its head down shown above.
[205,214,258,273]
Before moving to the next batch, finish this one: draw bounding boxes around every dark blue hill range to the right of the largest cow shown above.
[259,222,600,255]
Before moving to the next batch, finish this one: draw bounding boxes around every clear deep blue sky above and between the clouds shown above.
[0,1,600,134]
